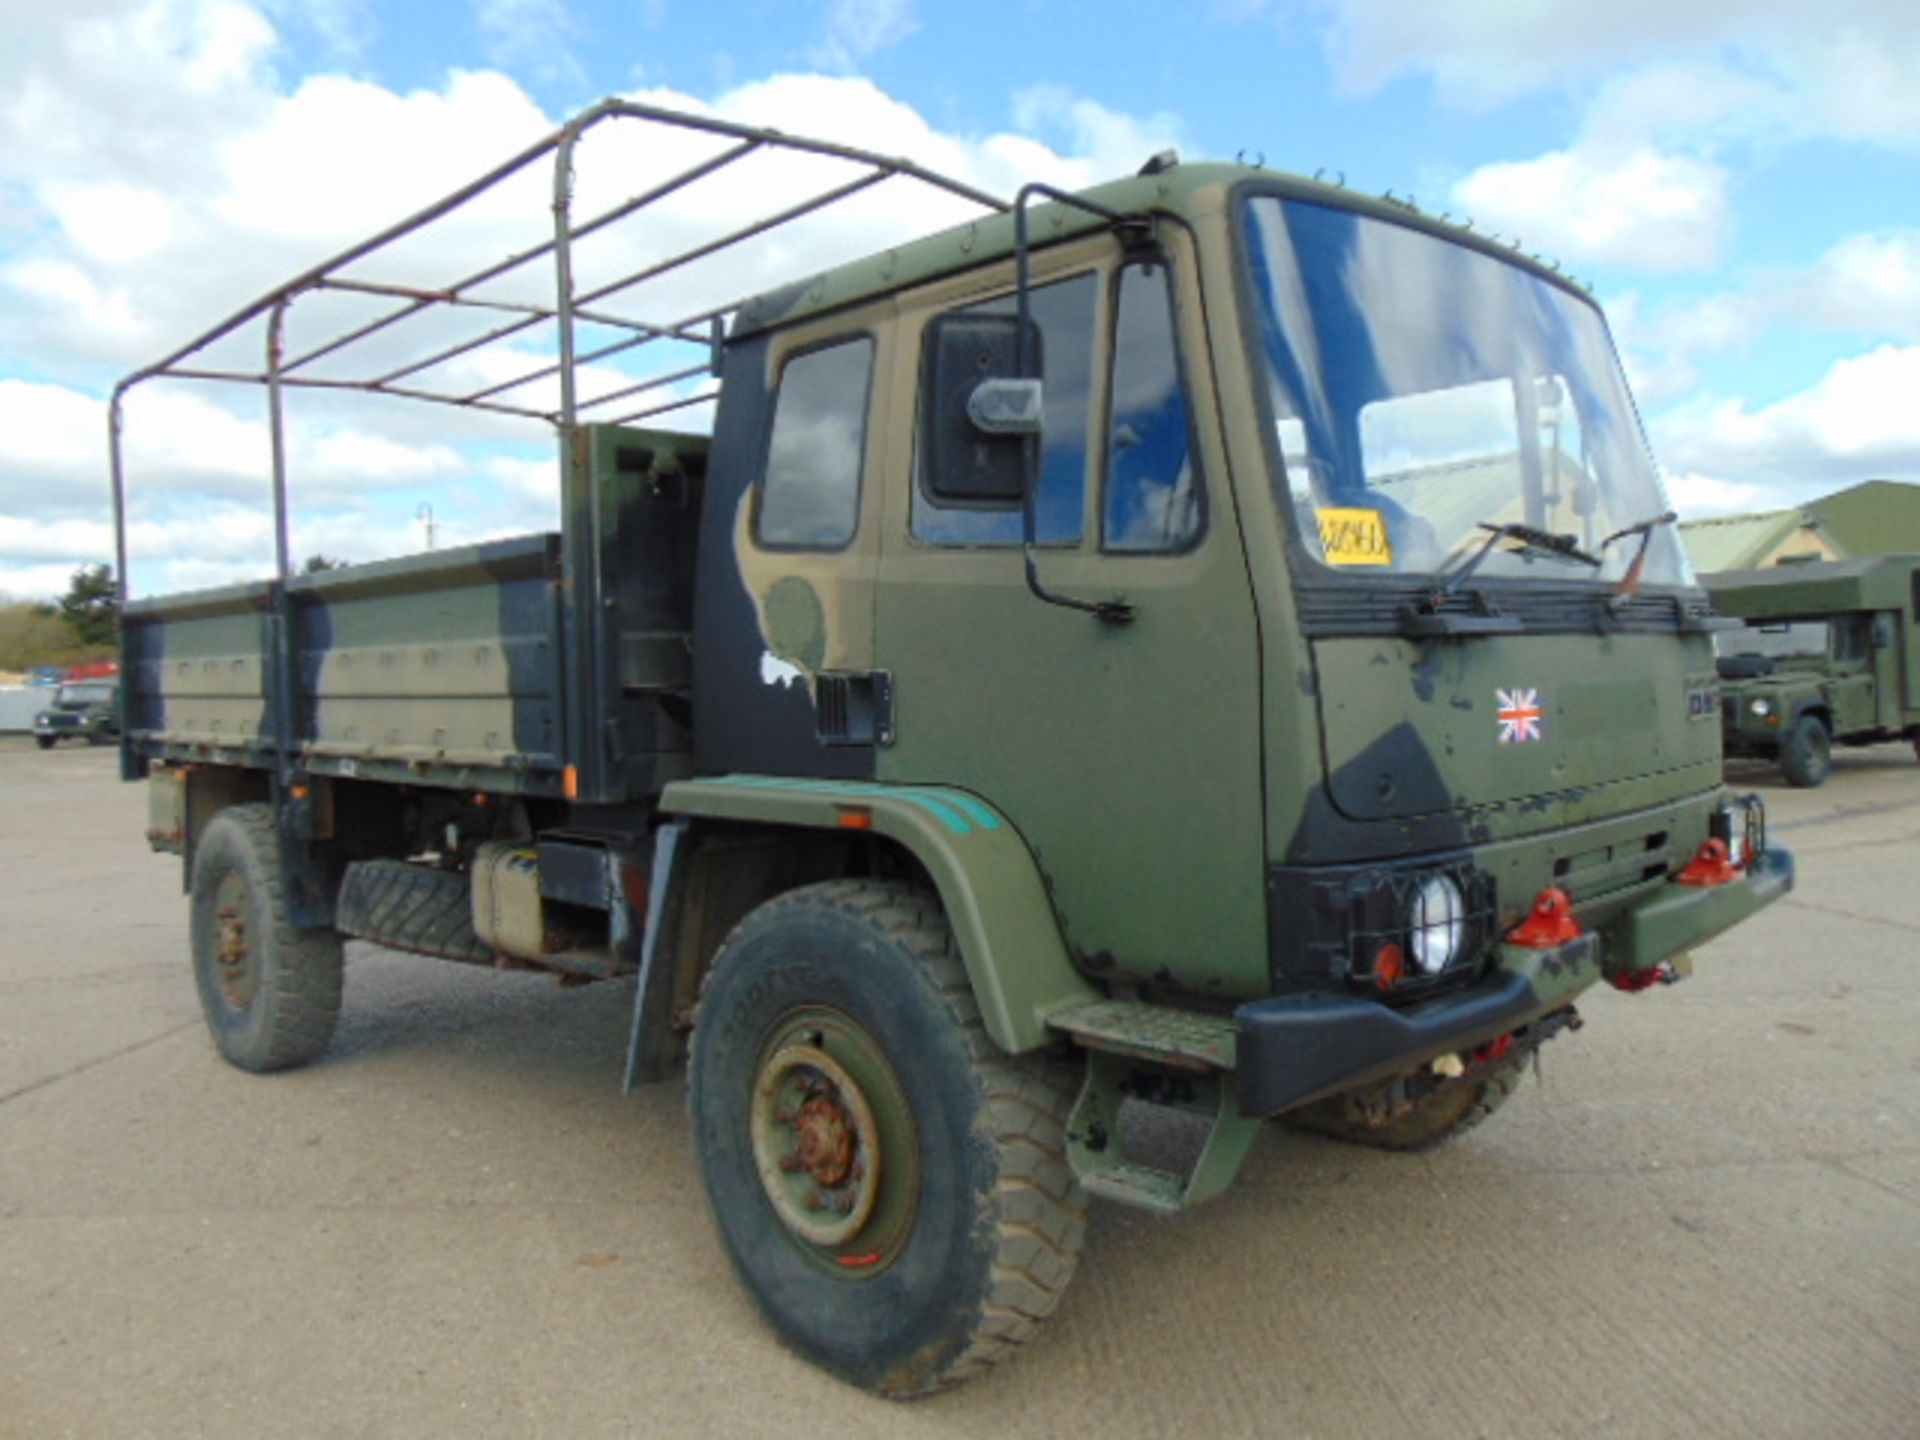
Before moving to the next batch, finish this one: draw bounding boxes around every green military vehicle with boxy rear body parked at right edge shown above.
[1701,555,1920,785]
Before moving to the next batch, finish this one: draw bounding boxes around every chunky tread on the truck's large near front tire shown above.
[693,879,1087,1398]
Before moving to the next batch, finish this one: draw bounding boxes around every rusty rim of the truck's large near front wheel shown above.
[753,1008,920,1279]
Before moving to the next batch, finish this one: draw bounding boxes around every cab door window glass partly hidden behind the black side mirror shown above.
[912,275,1098,545]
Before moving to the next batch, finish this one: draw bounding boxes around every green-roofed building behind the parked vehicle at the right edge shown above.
[1680,480,1920,574]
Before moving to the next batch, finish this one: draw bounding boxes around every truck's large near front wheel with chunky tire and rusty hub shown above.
[687,881,1087,1398]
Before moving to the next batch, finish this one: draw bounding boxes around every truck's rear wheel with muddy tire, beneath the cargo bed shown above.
[188,804,342,1071]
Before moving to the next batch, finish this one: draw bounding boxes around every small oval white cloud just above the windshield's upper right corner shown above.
[1453,148,1730,271]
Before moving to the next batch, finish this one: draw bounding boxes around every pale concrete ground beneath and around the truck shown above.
[0,739,1920,1440]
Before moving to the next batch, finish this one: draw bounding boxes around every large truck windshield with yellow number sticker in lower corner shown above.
[1244,196,1692,584]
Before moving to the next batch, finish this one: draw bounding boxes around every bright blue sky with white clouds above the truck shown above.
[0,0,1920,597]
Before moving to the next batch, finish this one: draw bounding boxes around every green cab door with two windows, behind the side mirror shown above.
[876,234,1267,995]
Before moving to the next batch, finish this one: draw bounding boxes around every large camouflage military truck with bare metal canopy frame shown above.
[113,102,1793,1396]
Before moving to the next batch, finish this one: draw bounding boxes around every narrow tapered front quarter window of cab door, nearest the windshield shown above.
[1100,265,1202,555]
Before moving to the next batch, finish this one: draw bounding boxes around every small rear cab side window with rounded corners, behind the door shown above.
[755,336,874,549]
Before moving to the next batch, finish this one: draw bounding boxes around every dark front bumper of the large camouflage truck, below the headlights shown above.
[1235,849,1793,1116]
